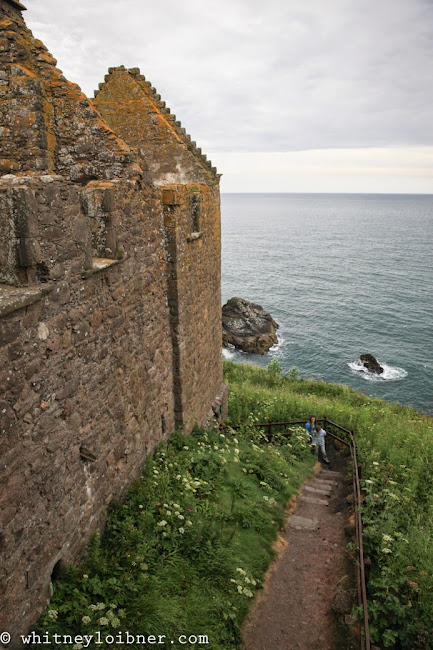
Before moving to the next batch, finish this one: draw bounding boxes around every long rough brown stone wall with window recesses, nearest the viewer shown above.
[0,171,174,631]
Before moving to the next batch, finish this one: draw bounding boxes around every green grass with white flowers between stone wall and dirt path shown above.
[38,412,314,650]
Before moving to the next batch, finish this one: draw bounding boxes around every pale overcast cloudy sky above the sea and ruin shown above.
[23,0,433,194]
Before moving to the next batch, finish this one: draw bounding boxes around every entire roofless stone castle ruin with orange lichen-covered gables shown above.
[0,0,226,634]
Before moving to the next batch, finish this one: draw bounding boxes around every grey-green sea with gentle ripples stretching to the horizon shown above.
[221,194,433,414]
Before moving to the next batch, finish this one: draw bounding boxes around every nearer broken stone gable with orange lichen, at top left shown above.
[0,0,140,183]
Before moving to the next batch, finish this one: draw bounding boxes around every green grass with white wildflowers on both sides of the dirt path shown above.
[38,362,433,650]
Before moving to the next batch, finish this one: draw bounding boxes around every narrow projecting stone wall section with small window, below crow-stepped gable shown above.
[162,184,222,430]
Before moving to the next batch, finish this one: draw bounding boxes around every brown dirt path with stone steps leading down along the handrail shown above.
[244,449,356,650]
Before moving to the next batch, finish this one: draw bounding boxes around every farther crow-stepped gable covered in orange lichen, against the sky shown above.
[94,65,220,185]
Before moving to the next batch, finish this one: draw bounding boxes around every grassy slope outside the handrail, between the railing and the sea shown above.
[225,362,433,648]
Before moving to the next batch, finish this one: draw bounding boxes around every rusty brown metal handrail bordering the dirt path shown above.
[222,415,371,650]
